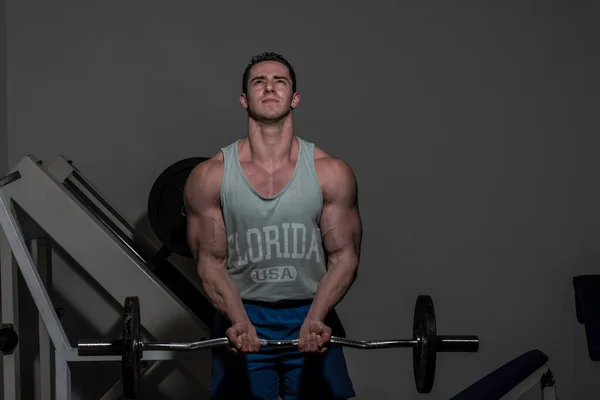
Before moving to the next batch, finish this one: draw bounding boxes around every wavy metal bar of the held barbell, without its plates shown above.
[77,335,479,356]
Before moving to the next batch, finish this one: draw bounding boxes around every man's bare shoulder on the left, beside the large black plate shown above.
[184,152,223,204]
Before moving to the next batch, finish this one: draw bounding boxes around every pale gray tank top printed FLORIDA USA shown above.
[220,138,326,302]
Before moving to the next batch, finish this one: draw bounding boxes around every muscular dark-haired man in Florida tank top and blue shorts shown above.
[184,53,362,400]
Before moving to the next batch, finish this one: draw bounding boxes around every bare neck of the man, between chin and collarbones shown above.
[248,118,294,168]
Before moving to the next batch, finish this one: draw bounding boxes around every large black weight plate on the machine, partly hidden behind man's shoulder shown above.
[148,157,208,258]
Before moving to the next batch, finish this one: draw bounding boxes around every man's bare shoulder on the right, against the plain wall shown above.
[314,146,357,200]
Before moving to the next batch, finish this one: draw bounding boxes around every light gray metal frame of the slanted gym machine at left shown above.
[0,156,210,400]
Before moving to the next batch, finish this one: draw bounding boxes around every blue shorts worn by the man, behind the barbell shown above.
[210,302,356,400]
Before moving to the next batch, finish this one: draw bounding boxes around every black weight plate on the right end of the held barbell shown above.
[413,295,437,393]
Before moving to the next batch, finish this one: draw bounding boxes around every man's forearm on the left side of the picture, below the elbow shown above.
[198,259,248,324]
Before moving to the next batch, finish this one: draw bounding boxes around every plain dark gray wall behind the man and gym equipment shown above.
[0,0,600,399]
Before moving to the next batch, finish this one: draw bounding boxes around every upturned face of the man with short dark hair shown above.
[240,61,300,122]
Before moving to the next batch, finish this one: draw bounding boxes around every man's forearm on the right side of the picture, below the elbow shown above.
[306,250,358,321]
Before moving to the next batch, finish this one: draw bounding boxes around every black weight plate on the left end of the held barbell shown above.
[121,297,142,399]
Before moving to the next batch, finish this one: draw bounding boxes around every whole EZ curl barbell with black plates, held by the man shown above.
[77,295,479,399]
